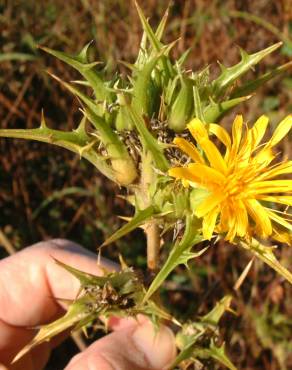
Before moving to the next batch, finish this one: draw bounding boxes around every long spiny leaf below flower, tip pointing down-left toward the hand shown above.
[144,215,203,302]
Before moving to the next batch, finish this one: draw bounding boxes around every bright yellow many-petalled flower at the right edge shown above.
[169,115,292,241]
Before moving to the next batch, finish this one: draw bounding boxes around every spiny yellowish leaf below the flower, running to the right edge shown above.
[240,239,292,284]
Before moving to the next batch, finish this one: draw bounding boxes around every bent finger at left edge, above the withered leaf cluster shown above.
[0,239,115,369]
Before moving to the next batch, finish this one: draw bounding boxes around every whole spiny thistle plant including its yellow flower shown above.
[0,4,292,369]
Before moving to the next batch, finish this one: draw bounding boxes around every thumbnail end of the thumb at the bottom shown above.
[133,322,176,370]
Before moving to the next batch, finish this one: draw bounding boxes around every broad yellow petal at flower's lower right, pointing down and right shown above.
[244,199,273,237]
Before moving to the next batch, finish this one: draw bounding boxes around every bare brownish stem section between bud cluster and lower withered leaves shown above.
[145,220,160,271]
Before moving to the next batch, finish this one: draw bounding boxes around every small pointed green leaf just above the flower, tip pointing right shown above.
[204,95,252,123]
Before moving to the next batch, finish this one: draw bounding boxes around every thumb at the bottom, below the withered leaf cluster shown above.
[65,321,176,370]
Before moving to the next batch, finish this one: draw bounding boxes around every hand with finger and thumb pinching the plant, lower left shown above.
[0,239,176,370]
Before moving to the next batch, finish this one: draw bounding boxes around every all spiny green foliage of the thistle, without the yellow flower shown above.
[0,3,292,370]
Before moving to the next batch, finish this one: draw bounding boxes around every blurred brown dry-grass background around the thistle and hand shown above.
[0,0,292,370]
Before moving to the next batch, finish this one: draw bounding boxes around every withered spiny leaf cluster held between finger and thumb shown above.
[13,260,172,362]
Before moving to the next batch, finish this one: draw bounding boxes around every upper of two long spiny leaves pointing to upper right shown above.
[213,42,282,97]
